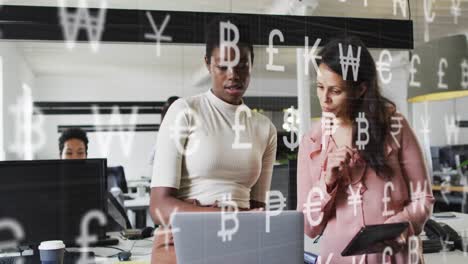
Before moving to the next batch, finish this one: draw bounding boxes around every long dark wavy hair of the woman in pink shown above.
[318,36,396,179]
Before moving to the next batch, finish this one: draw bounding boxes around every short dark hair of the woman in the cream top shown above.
[205,16,254,63]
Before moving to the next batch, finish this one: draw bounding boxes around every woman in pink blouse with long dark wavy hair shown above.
[297,37,434,264]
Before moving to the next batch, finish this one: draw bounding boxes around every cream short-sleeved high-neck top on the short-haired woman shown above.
[151,91,277,208]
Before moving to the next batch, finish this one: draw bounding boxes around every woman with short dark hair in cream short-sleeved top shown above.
[150,18,277,264]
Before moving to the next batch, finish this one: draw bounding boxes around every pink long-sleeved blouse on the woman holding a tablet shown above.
[297,114,434,264]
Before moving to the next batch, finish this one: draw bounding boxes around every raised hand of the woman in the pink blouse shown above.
[325,146,356,190]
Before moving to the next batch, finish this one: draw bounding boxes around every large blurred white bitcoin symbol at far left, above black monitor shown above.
[10,84,45,160]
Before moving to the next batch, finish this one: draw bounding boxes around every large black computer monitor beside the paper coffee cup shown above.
[0,159,107,246]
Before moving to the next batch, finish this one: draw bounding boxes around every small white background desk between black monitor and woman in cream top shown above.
[124,194,153,228]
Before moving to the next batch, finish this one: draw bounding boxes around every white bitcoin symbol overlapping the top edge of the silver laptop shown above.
[218,193,239,242]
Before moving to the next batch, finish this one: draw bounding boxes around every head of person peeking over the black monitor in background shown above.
[59,128,88,159]
